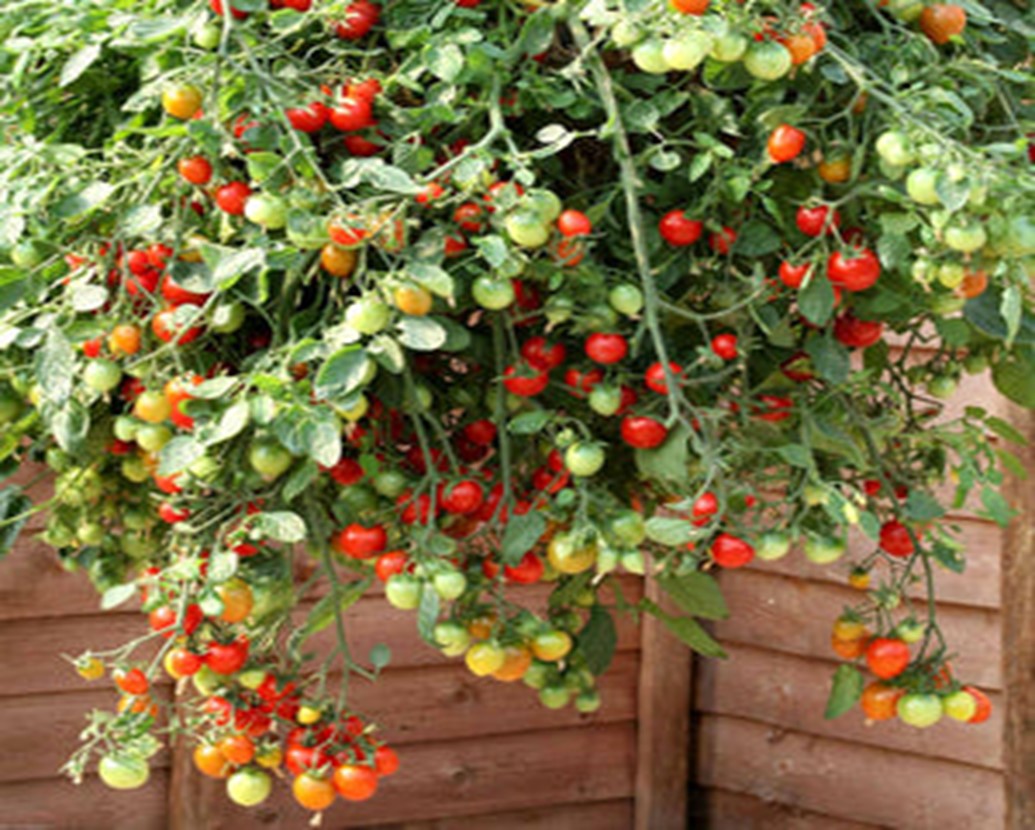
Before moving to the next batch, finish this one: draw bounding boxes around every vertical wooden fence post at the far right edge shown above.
[1002,399,1035,830]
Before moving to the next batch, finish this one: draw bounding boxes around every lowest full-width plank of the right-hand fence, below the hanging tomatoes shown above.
[697,715,1004,830]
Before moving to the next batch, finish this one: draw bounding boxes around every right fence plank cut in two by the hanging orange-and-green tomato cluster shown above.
[714,570,1003,689]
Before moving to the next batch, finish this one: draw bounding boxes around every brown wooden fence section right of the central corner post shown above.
[691,368,1006,830]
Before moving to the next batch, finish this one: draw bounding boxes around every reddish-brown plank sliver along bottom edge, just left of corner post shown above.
[368,799,632,830]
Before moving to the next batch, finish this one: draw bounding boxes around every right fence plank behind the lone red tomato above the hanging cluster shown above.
[748,518,1003,609]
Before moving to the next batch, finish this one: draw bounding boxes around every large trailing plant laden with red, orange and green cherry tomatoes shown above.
[0,0,1035,810]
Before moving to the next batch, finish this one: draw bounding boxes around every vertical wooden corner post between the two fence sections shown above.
[635,577,692,830]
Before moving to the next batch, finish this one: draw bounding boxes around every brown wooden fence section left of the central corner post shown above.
[0,461,642,830]
